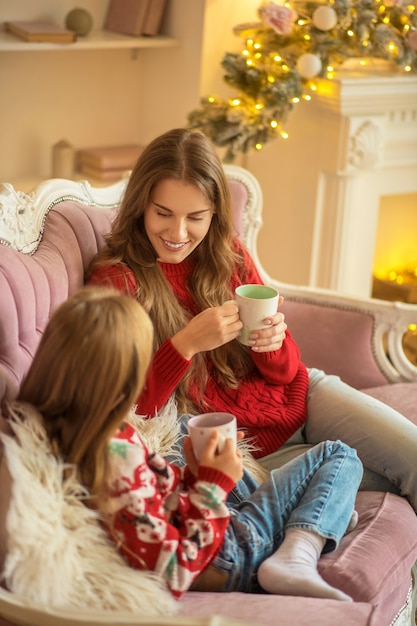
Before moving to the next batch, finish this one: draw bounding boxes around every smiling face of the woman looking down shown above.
[144,178,213,263]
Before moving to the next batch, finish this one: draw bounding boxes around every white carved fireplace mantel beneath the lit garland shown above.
[309,73,417,296]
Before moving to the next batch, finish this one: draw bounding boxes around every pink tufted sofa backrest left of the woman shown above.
[0,200,112,400]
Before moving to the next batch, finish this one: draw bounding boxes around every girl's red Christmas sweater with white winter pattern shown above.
[104,427,234,598]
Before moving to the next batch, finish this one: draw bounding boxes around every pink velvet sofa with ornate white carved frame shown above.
[0,166,417,626]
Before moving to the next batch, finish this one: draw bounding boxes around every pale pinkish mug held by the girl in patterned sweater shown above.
[188,413,237,461]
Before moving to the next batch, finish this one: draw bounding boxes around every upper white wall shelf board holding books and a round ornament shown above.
[0,30,179,52]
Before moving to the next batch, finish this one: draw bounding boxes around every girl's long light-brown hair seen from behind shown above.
[17,287,153,497]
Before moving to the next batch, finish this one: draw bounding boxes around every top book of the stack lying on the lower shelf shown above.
[77,143,143,170]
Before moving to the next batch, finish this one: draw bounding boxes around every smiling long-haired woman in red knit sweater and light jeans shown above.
[89,129,417,510]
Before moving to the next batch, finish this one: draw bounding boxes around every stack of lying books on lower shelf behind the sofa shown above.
[77,144,143,181]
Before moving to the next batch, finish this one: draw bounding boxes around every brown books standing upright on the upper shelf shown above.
[104,0,167,36]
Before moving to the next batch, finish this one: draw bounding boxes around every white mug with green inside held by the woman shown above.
[235,285,279,346]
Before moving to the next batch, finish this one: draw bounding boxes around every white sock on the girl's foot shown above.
[258,528,352,602]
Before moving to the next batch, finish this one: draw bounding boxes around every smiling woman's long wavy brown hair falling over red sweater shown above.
[90,128,252,413]
